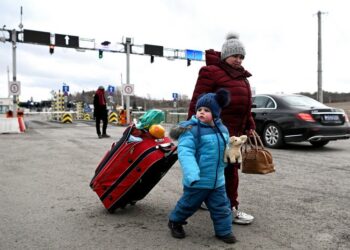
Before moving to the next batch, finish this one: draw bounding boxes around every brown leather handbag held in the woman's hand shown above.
[242,131,275,174]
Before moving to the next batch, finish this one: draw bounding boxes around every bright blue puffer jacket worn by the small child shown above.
[178,116,229,189]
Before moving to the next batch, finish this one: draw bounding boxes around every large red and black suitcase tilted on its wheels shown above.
[90,125,177,212]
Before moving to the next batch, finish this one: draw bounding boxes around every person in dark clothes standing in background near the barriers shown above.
[94,86,110,138]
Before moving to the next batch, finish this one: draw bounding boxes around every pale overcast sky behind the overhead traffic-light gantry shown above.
[0,0,350,101]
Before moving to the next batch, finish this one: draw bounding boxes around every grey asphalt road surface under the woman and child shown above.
[0,117,350,250]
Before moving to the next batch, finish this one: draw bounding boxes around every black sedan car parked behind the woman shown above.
[252,94,350,148]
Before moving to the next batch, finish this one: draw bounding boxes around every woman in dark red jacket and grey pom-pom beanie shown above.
[187,33,255,224]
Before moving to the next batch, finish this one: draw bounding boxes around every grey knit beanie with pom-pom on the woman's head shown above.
[221,32,245,60]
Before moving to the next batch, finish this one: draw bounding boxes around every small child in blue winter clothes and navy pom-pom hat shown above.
[168,89,236,243]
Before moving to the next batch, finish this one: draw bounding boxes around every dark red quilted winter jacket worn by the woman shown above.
[188,50,255,136]
